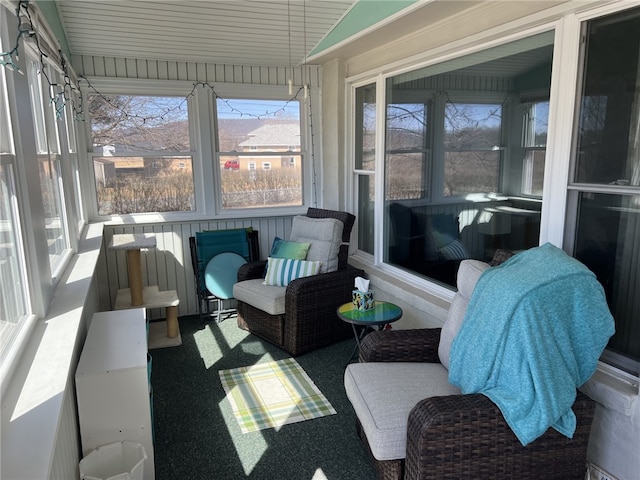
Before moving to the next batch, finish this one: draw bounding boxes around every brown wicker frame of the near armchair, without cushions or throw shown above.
[356,328,595,480]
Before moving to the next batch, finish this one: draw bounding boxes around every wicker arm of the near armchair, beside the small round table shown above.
[360,328,441,363]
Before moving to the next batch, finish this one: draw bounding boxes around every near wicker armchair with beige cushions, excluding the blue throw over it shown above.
[345,253,595,480]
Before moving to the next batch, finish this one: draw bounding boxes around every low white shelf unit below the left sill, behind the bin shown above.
[76,308,155,480]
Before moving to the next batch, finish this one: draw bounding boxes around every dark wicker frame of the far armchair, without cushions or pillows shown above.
[236,208,364,356]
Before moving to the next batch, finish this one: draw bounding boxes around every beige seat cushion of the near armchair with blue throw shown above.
[344,362,460,460]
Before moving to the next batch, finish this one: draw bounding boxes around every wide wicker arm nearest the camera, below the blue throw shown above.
[404,392,595,480]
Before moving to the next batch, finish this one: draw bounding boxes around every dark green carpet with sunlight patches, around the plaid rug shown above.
[151,316,375,480]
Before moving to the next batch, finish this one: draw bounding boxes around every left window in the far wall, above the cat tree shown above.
[88,94,196,216]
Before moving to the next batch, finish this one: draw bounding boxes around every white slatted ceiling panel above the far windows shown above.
[56,0,355,66]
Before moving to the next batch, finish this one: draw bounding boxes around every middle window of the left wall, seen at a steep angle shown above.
[27,58,70,278]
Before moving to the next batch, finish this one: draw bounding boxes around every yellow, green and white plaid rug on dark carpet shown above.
[218,358,336,433]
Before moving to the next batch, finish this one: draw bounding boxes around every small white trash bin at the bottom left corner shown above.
[80,441,147,480]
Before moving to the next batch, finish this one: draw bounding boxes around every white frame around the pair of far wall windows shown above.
[80,77,319,223]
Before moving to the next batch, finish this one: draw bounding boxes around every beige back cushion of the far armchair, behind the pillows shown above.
[289,215,344,273]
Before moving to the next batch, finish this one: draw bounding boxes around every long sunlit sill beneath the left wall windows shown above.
[0,224,103,479]
